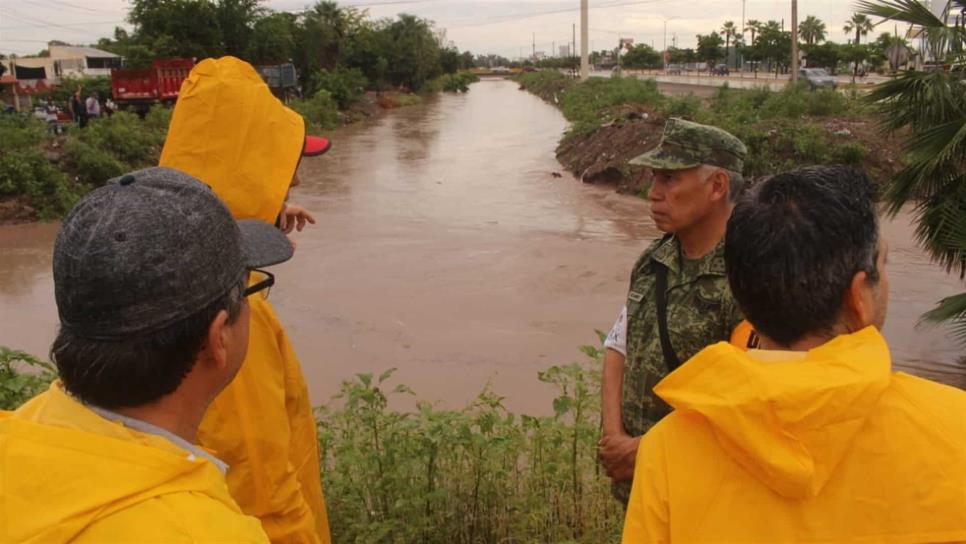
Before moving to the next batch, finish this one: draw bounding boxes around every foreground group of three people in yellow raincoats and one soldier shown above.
[0,53,966,544]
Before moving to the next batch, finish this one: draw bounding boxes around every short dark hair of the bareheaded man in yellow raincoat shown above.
[725,166,879,345]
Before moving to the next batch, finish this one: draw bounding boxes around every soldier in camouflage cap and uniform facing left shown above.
[598,118,746,505]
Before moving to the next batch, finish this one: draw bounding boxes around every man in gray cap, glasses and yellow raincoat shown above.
[0,168,292,544]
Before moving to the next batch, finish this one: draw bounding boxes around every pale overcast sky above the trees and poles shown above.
[0,0,892,57]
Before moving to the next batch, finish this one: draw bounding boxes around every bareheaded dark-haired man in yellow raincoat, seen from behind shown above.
[623,167,966,544]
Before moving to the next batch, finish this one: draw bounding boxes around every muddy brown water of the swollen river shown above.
[0,81,966,413]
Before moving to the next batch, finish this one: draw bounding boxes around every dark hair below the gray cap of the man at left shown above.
[50,283,244,409]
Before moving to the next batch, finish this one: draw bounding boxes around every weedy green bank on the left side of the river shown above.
[0,72,478,225]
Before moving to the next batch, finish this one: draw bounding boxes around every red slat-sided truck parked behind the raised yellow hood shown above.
[111,59,195,111]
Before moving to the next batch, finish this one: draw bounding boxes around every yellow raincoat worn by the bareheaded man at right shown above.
[623,327,966,544]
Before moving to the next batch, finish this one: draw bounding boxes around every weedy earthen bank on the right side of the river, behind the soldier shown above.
[516,71,902,194]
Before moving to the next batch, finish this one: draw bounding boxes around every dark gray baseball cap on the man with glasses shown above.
[54,168,293,340]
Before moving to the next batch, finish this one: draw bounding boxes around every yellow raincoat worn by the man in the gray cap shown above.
[0,383,268,544]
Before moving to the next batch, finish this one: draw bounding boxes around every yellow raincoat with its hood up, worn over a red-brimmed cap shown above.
[160,57,330,543]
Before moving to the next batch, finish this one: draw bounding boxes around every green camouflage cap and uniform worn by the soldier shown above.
[613,119,746,504]
